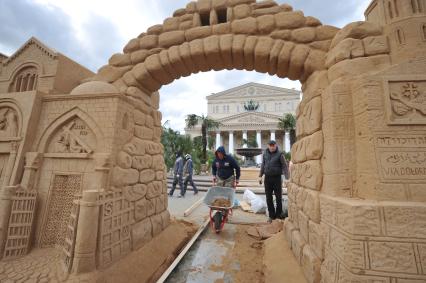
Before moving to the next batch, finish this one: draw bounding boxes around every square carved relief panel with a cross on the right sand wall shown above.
[387,81,426,124]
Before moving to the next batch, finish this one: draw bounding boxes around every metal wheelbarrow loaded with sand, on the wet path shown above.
[204,187,235,233]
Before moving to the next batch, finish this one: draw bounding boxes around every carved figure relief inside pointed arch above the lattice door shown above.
[49,118,96,153]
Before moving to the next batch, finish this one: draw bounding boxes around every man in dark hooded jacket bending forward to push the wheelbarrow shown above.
[212,146,241,188]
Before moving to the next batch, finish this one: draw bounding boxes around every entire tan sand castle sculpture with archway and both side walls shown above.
[0,0,426,283]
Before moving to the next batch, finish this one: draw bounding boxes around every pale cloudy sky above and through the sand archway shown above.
[0,0,371,131]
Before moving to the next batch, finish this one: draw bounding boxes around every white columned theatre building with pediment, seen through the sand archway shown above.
[185,82,301,163]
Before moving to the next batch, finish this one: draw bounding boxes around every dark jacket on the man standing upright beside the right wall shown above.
[260,147,288,179]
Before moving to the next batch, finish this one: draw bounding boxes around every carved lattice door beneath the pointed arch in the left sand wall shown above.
[41,174,82,247]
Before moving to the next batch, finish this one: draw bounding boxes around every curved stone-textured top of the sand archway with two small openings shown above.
[91,0,338,94]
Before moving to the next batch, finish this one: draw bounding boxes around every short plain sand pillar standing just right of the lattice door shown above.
[72,191,99,273]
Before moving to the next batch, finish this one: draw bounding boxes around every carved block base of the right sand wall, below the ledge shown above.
[321,196,426,282]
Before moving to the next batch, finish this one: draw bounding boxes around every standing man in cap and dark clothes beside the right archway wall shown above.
[259,140,288,222]
